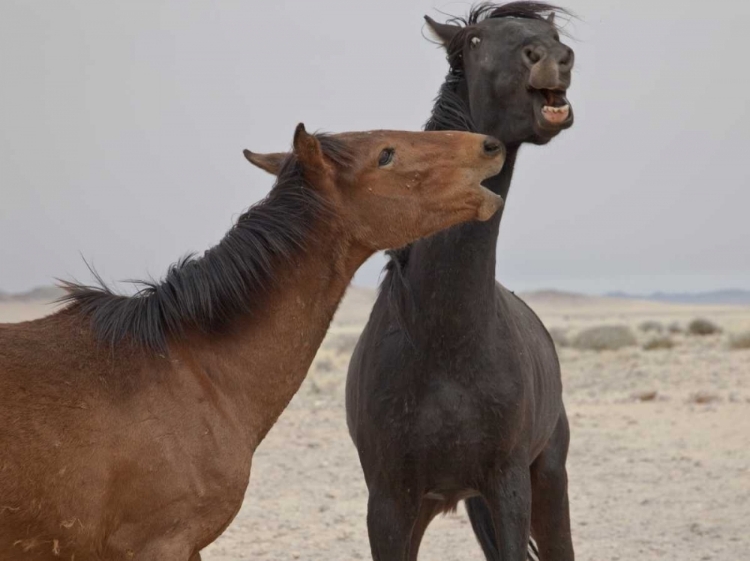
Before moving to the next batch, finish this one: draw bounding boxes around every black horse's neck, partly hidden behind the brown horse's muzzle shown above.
[387,77,518,336]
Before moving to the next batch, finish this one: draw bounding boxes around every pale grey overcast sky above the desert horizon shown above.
[0,0,750,293]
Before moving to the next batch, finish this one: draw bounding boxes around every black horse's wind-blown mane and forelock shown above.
[380,1,571,324]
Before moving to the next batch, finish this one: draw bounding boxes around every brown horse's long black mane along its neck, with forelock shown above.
[60,134,352,352]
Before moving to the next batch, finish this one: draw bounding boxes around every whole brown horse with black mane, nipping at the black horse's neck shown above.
[0,125,505,561]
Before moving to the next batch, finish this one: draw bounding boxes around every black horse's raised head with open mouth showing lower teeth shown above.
[425,2,574,146]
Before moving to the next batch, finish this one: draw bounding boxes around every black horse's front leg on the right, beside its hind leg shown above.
[466,462,531,561]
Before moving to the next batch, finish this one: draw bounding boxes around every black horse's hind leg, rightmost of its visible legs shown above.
[531,411,574,561]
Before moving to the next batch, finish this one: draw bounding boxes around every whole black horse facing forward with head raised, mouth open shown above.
[346,2,573,561]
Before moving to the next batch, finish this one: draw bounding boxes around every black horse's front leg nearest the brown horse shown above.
[367,487,420,561]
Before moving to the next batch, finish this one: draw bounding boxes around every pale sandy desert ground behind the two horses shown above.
[0,288,750,561]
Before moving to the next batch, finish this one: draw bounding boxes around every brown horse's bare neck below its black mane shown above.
[175,218,372,446]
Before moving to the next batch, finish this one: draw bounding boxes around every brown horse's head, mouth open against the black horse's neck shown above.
[245,124,505,250]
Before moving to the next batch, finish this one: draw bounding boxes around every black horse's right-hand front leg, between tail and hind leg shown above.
[481,461,532,561]
